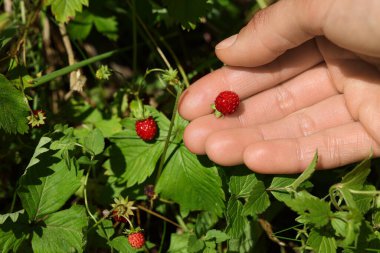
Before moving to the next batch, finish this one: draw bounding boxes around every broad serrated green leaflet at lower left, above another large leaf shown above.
[17,148,82,220]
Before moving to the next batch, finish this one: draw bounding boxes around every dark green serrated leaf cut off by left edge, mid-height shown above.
[0,74,29,134]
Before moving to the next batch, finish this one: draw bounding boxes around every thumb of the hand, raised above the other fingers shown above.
[216,0,380,67]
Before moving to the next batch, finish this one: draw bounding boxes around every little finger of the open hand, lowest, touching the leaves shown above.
[244,122,380,174]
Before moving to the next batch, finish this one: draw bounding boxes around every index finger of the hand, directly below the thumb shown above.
[179,42,322,120]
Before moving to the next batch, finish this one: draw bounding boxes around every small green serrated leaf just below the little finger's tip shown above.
[229,174,257,198]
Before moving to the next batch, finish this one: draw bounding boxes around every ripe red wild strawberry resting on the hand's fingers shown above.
[212,91,240,118]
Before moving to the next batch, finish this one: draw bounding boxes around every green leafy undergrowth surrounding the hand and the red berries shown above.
[0,0,380,253]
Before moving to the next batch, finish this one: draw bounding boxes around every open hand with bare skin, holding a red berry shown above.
[179,0,380,174]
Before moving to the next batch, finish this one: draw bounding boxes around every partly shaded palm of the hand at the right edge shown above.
[318,38,380,143]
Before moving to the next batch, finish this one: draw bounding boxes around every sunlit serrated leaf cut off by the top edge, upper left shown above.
[46,0,88,23]
